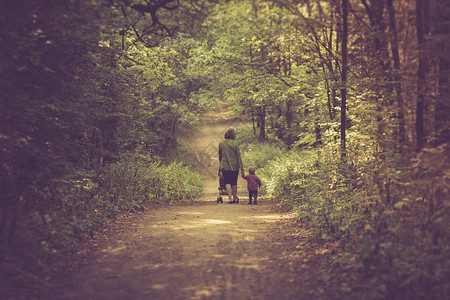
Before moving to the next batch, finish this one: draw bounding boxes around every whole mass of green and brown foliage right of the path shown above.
[207,0,450,299]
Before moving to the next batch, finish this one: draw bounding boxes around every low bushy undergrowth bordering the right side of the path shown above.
[241,132,450,299]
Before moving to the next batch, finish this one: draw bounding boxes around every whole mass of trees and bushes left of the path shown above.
[0,0,208,292]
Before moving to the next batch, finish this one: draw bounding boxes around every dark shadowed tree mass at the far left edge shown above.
[0,0,104,250]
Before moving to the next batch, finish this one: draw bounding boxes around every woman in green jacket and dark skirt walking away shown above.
[219,128,244,204]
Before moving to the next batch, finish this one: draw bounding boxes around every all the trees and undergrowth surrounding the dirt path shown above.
[0,0,450,299]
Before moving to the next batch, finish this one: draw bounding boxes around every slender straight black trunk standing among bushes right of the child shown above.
[341,0,348,159]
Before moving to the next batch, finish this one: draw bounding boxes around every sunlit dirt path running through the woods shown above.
[34,109,354,300]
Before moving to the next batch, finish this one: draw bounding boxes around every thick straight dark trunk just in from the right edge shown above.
[416,0,428,152]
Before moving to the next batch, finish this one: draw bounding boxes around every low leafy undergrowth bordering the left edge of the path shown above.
[0,154,203,290]
